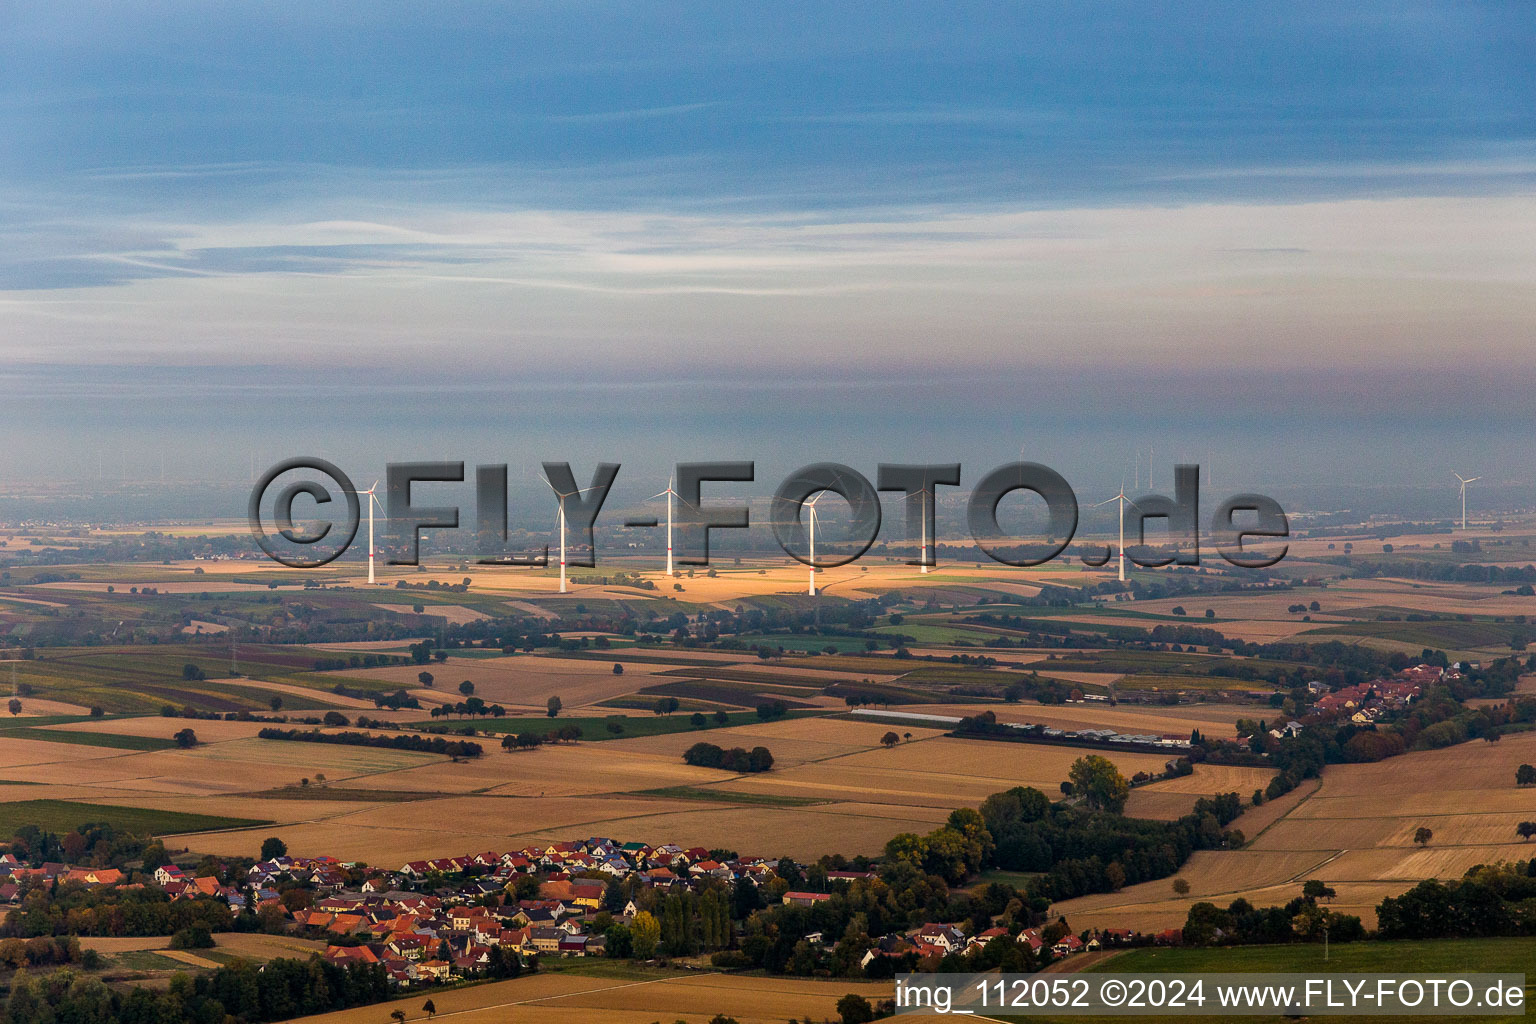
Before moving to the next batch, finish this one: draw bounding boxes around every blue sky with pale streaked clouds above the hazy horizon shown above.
[0,0,1536,504]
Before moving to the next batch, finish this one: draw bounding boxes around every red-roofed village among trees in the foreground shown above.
[0,837,1180,989]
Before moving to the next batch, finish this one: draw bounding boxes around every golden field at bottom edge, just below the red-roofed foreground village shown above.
[288,973,892,1024]
